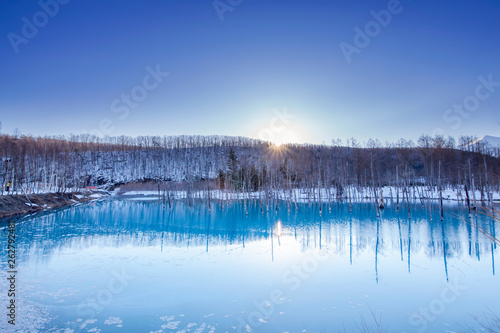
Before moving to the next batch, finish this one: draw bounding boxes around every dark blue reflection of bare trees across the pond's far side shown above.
[1,200,495,269]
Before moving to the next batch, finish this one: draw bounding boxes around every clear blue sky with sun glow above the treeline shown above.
[0,0,500,143]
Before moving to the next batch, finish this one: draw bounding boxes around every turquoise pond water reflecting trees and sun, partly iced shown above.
[0,198,500,333]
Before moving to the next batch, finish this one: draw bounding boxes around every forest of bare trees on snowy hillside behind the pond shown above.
[0,134,500,202]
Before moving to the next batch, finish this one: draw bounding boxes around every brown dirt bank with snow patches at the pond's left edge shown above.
[0,192,105,219]
